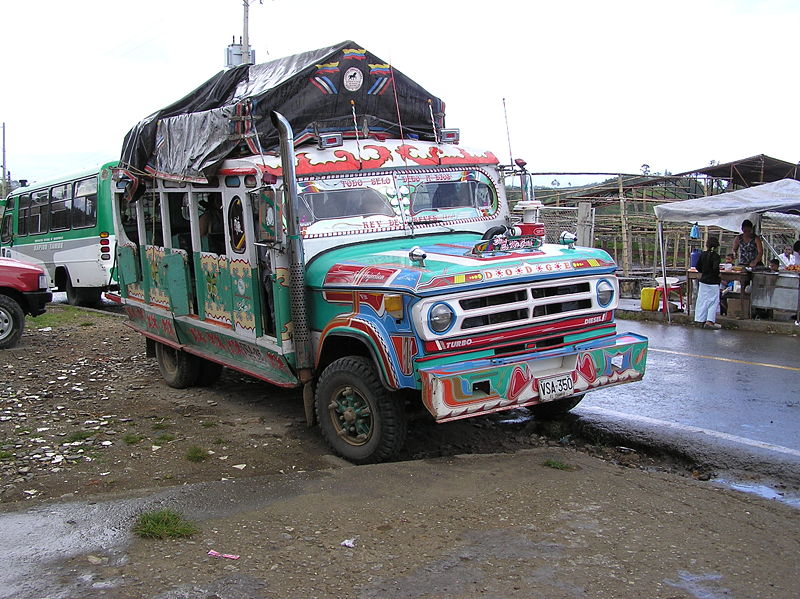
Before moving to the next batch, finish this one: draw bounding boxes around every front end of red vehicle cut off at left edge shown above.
[0,258,53,349]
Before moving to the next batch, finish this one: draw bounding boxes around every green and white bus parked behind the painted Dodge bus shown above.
[0,162,117,306]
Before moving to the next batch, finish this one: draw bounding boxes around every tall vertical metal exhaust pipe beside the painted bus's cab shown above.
[270,111,313,380]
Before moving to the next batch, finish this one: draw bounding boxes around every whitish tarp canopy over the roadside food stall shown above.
[655,179,800,233]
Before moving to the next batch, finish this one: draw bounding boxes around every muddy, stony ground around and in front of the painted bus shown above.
[0,306,800,599]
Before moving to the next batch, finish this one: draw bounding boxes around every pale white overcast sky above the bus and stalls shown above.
[0,0,800,185]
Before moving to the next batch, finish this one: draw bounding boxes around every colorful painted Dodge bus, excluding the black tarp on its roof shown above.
[114,113,647,463]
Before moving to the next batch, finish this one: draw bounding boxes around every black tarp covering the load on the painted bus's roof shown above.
[120,41,444,179]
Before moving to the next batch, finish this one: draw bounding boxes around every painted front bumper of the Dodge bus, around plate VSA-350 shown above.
[419,333,647,422]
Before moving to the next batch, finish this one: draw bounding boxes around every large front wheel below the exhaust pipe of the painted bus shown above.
[314,356,407,464]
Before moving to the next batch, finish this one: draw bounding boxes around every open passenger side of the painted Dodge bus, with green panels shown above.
[114,172,299,387]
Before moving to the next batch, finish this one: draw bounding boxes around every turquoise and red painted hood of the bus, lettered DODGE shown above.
[306,233,617,295]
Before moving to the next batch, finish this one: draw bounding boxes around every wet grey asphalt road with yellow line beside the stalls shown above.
[574,321,800,482]
